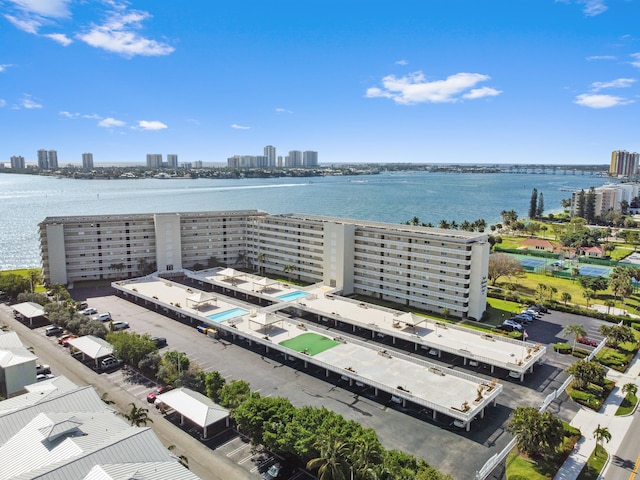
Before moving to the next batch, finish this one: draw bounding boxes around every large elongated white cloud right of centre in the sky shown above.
[366,71,501,105]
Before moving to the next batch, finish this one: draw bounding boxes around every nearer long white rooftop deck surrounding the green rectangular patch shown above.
[112,276,502,428]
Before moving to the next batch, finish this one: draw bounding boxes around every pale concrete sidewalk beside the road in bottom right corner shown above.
[553,355,640,480]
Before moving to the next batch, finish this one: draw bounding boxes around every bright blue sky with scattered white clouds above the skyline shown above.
[0,0,640,164]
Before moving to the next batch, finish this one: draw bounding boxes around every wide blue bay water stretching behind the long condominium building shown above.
[0,171,607,270]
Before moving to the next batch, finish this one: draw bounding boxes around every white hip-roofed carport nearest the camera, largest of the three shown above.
[156,387,229,440]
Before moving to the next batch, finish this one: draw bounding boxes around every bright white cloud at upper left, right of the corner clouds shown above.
[77,10,175,57]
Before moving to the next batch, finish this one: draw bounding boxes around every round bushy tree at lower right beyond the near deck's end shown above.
[507,407,564,456]
